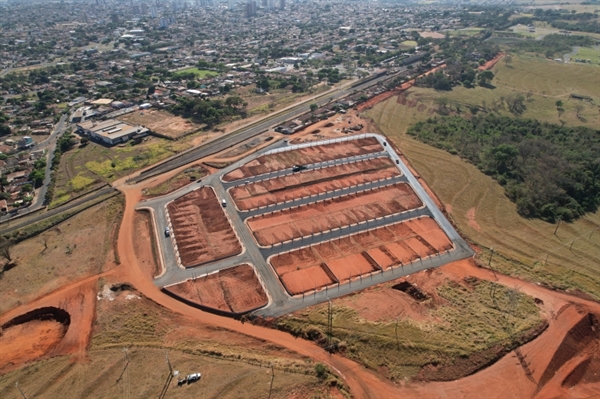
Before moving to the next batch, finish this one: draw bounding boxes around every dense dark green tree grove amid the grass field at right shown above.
[408,115,600,222]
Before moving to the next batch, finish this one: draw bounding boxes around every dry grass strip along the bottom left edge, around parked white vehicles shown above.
[0,347,325,399]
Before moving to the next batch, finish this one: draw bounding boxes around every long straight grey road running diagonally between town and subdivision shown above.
[132,68,405,183]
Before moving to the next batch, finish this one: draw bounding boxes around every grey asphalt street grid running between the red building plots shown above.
[138,134,473,316]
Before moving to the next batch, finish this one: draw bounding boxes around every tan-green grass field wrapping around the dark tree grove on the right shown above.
[368,57,600,298]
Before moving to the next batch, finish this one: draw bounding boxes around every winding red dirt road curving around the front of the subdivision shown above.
[0,138,600,399]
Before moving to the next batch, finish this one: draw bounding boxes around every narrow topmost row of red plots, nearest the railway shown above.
[223,137,383,182]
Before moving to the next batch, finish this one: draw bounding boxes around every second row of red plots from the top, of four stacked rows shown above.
[229,157,400,211]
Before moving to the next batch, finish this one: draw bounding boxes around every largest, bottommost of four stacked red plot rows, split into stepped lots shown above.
[269,216,452,295]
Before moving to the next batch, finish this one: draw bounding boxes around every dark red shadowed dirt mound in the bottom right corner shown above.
[538,313,600,388]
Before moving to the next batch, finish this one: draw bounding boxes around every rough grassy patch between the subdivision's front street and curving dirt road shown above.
[276,280,542,381]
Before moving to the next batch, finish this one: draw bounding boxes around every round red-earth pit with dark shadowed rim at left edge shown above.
[0,307,71,371]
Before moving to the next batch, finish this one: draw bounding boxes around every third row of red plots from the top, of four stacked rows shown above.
[247,183,422,246]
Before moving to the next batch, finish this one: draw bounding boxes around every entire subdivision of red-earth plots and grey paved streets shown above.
[138,134,472,316]
